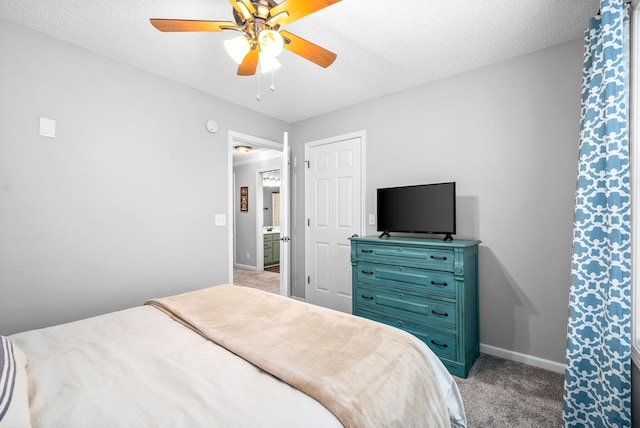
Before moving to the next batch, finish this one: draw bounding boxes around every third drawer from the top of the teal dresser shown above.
[353,287,457,331]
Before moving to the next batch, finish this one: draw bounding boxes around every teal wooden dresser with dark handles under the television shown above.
[351,237,480,377]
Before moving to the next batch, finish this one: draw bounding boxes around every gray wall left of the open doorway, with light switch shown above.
[0,19,290,334]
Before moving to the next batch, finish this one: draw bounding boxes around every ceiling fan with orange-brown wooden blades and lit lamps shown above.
[150,0,340,76]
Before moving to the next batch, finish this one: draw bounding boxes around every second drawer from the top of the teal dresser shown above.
[356,263,456,298]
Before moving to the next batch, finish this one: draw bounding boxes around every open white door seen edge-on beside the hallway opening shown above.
[280,132,291,296]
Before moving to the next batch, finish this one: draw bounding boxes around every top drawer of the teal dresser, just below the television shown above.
[355,244,454,271]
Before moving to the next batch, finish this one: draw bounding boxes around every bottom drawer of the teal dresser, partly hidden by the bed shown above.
[355,308,457,360]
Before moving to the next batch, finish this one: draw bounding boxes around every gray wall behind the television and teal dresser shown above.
[291,40,582,363]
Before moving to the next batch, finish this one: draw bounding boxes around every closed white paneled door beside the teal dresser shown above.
[305,133,365,313]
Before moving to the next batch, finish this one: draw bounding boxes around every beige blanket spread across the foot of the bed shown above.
[147,285,450,428]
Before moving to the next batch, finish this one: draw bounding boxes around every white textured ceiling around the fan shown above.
[0,0,599,123]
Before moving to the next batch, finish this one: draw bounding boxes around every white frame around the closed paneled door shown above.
[304,130,367,301]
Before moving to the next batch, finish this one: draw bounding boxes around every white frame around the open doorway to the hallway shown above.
[227,130,284,284]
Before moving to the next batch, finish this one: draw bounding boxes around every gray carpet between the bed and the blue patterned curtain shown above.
[454,354,564,428]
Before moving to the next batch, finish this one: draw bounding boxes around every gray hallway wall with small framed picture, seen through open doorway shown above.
[233,157,282,267]
